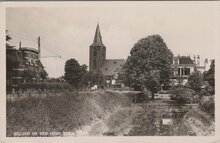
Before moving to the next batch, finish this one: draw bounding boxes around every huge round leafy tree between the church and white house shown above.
[122,35,173,98]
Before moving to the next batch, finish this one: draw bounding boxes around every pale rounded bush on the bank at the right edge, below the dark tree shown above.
[200,96,215,116]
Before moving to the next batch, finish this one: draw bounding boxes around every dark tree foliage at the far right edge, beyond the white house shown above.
[203,60,215,95]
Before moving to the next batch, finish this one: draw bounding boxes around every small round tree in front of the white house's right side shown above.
[188,71,203,92]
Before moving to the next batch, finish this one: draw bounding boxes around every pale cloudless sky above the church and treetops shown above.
[6,2,220,77]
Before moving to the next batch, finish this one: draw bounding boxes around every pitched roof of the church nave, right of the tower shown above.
[101,59,125,76]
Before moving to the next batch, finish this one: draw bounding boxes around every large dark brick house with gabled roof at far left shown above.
[6,37,46,87]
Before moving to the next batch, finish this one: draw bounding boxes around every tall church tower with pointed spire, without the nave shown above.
[89,24,106,72]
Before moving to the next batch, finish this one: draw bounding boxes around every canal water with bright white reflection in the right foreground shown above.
[128,106,193,136]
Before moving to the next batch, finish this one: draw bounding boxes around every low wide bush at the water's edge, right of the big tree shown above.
[171,86,193,104]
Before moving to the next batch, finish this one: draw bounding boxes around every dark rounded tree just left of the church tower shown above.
[64,59,82,89]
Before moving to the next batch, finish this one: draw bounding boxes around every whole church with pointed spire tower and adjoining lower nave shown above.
[89,24,125,87]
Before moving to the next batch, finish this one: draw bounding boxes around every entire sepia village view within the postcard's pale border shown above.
[3,1,220,138]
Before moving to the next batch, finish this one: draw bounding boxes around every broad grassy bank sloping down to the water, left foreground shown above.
[7,91,130,136]
